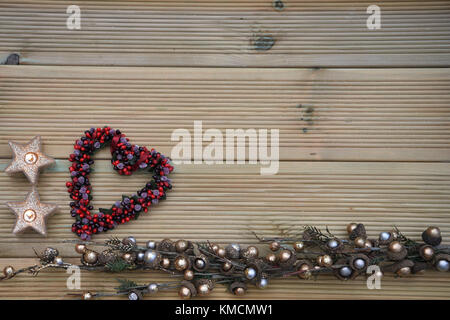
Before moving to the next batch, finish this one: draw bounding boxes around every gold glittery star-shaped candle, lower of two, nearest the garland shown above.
[6,187,58,236]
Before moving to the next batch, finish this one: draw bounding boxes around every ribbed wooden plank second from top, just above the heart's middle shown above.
[0,66,450,161]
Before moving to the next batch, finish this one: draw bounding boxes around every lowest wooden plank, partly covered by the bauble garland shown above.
[0,258,450,300]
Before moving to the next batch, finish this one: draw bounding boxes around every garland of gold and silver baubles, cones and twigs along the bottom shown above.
[0,223,450,300]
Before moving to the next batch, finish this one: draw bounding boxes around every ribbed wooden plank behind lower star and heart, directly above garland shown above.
[0,160,450,257]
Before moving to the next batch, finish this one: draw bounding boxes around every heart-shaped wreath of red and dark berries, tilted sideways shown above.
[66,127,173,240]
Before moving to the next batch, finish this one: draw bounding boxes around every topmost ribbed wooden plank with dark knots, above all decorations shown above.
[0,0,450,67]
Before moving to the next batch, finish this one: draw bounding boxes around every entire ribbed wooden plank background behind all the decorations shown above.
[0,0,450,299]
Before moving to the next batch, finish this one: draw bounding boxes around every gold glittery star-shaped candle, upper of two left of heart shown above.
[5,136,55,184]
